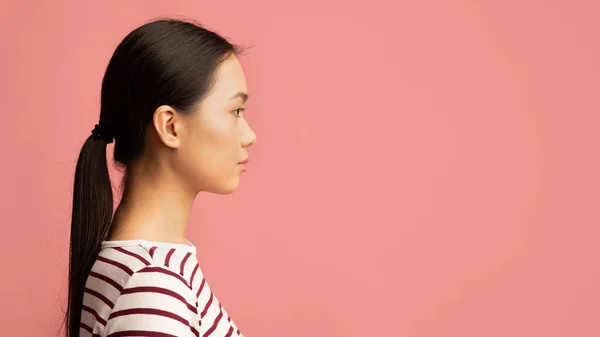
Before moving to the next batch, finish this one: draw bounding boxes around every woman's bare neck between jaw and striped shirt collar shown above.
[107,160,195,244]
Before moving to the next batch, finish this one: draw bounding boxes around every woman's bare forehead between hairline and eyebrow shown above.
[213,56,248,99]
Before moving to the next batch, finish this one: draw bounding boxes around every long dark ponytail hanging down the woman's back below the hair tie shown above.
[66,135,113,337]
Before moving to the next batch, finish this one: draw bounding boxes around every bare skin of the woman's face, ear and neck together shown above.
[107,56,256,245]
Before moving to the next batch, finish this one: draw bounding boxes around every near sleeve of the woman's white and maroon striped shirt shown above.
[105,266,199,337]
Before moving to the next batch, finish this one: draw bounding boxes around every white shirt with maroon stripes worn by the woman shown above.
[80,240,243,337]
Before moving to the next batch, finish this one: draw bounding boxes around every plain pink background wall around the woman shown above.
[0,0,600,337]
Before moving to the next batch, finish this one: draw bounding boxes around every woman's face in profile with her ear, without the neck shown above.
[153,56,256,194]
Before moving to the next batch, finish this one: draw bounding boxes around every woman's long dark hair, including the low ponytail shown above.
[65,19,242,337]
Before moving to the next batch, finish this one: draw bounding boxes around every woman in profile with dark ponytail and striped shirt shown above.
[66,20,256,337]
